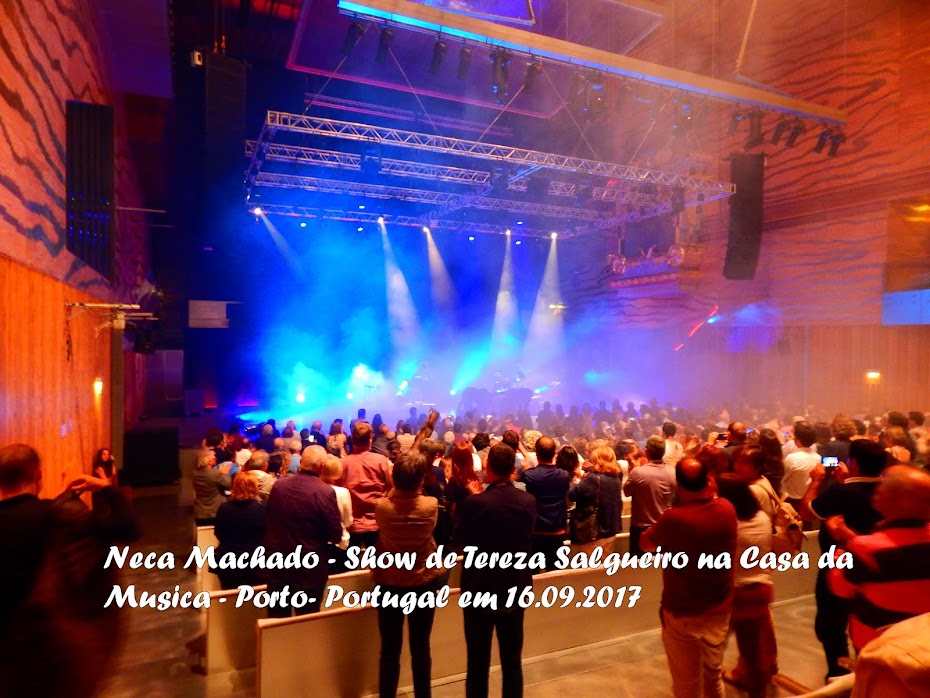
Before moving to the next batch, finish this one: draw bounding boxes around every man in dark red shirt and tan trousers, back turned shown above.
[631,456,737,698]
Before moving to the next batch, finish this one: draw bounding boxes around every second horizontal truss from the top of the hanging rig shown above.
[245,141,659,205]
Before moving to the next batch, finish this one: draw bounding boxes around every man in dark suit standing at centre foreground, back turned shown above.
[455,443,536,698]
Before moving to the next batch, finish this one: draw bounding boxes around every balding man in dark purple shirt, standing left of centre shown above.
[264,446,342,618]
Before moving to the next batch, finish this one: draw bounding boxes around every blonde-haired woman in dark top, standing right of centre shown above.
[569,445,623,554]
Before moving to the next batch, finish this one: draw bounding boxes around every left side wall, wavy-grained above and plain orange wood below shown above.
[0,0,148,494]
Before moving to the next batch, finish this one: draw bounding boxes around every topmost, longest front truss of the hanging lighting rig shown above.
[260,111,736,196]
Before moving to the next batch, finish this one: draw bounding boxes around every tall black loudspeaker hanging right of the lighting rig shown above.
[723,153,765,280]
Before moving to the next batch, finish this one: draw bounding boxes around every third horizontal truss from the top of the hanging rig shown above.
[254,172,604,220]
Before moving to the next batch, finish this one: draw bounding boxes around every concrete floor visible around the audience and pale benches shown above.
[101,461,826,698]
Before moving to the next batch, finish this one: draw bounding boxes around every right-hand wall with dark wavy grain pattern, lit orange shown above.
[564,0,930,409]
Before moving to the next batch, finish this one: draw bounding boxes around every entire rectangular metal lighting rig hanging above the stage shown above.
[245,111,736,237]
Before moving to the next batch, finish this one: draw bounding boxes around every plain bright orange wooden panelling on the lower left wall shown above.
[0,256,110,496]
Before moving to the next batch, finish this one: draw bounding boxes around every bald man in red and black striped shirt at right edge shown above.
[826,465,930,652]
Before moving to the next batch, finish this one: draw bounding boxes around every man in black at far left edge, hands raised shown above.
[0,444,138,698]
